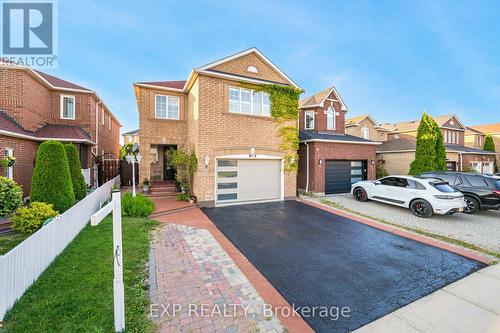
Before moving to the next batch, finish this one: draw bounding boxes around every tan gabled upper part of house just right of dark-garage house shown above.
[345,114,392,141]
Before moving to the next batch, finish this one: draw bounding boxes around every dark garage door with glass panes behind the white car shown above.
[325,160,367,194]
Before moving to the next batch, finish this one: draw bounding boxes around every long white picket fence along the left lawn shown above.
[0,177,120,321]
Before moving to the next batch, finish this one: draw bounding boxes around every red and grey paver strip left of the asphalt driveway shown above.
[150,223,284,333]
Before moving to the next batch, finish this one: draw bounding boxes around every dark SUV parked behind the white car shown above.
[420,171,500,214]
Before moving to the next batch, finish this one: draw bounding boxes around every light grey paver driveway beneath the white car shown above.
[311,194,500,252]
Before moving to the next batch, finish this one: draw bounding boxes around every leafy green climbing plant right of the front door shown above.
[166,148,198,193]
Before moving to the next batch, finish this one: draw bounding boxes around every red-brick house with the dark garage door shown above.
[297,87,380,195]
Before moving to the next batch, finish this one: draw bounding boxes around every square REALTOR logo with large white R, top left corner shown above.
[1,0,57,68]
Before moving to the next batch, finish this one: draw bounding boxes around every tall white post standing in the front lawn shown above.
[113,189,125,332]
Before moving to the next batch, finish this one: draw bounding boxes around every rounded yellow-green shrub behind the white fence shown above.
[12,202,57,234]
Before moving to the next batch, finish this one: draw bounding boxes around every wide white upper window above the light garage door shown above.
[229,87,271,116]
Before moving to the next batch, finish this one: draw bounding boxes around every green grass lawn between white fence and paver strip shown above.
[0,216,157,333]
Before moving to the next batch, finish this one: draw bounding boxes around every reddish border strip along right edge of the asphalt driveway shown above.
[297,198,494,265]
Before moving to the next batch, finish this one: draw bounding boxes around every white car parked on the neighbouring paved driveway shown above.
[352,176,467,217]
